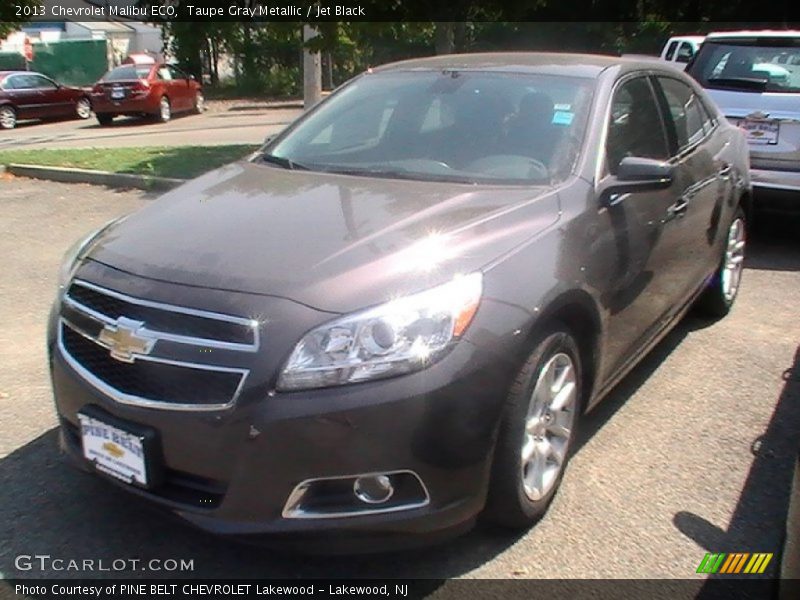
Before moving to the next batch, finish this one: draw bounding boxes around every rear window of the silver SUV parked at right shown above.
[689,38,800,92]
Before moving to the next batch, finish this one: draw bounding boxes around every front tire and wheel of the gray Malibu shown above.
[483,325,583,529]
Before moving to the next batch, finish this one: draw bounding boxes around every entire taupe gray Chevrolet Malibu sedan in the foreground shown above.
[48,54,751,551]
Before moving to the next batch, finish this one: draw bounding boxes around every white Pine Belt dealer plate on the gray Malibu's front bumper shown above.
[78,414,147,486]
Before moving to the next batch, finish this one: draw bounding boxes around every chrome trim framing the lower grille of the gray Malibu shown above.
[57,317,249,411]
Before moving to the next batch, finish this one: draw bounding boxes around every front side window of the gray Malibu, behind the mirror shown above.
[606,77,669,175]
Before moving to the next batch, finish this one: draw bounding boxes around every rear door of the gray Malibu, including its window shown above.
[654,75,732,300]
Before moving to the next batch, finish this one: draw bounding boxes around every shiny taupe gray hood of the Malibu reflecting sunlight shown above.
[89,162,558,313]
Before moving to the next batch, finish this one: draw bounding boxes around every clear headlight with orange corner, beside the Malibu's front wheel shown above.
[278,273,483,391]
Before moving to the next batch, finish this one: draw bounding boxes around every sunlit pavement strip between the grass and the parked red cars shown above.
[0,101,302,150]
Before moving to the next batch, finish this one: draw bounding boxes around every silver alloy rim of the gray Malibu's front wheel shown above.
[521,353,578,501]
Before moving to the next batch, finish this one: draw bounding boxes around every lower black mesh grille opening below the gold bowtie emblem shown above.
[61,322,244,405]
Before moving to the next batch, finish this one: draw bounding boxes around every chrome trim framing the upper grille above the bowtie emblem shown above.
[64,279,261,352]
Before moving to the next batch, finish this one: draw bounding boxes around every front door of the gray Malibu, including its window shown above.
[600,74,684,376]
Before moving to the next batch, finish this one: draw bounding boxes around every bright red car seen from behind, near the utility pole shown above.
[92,62,205,125]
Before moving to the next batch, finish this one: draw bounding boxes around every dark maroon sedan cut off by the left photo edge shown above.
[0,71,92,129]
